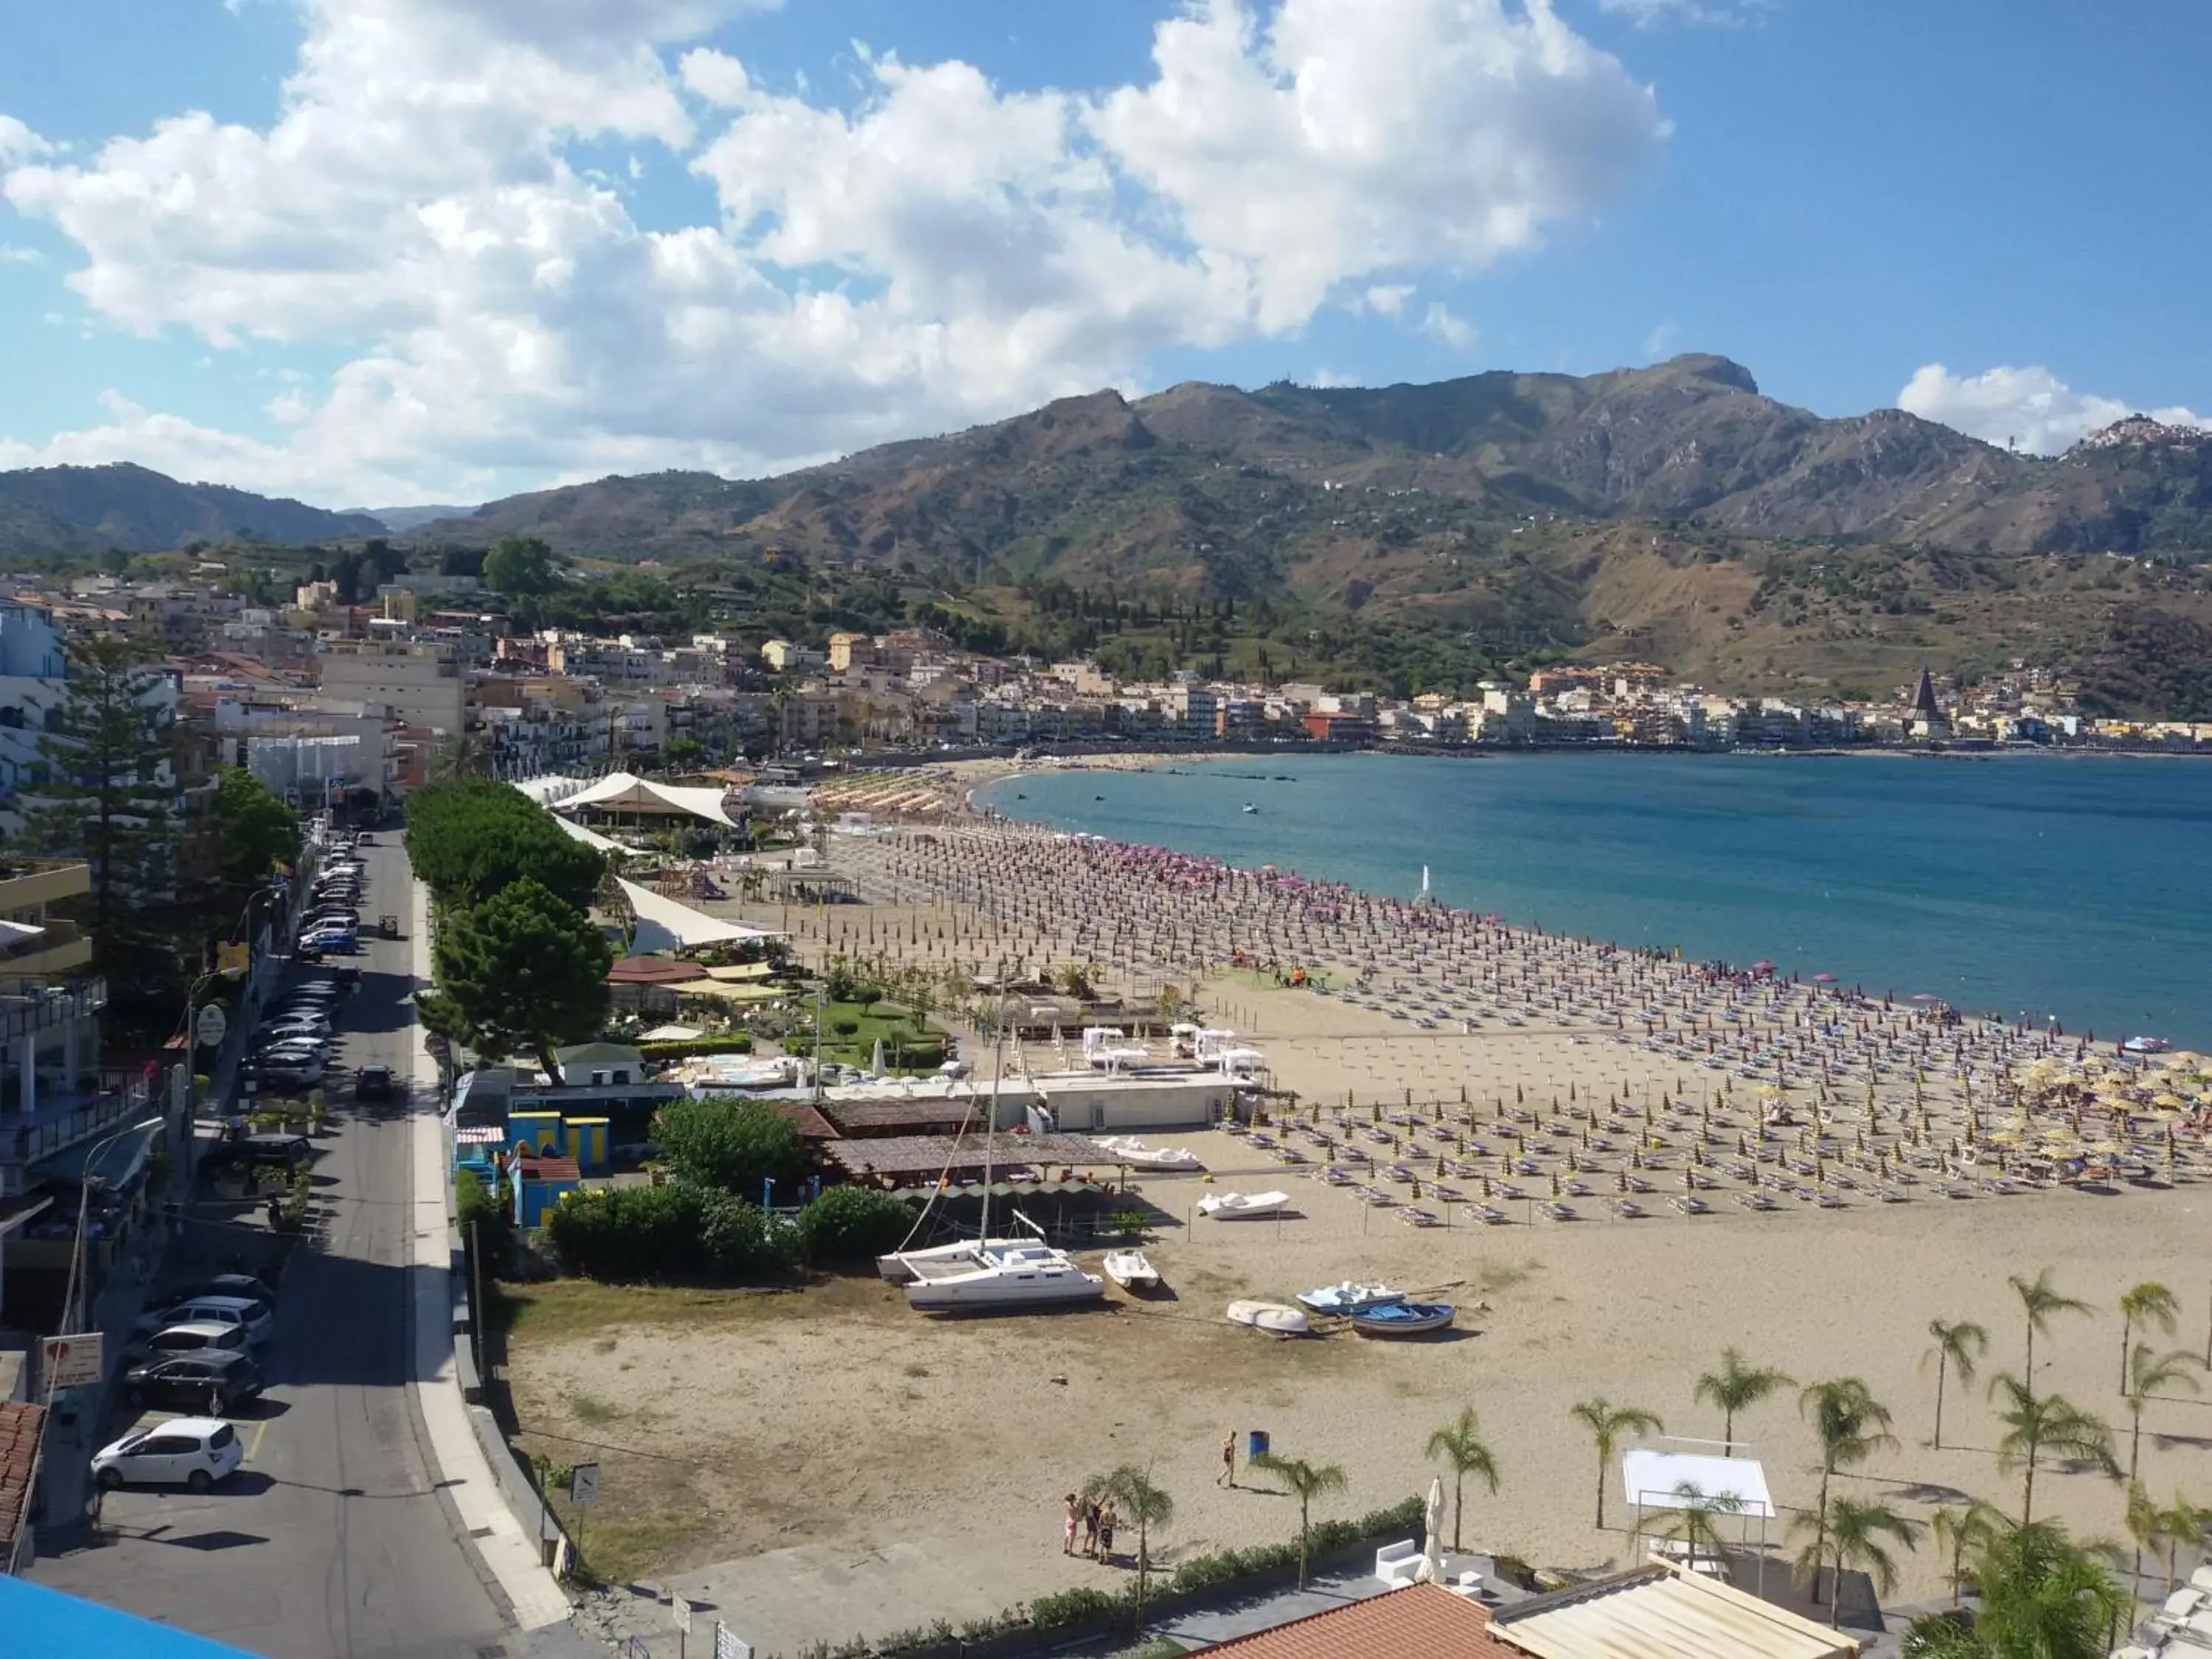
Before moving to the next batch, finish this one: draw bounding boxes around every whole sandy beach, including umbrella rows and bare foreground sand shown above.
[515,814,2212,1635]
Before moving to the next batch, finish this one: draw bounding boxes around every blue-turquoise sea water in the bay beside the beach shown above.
[978,754,2212,1048]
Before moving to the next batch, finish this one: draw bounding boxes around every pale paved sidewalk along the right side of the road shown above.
[409,883,571,1632]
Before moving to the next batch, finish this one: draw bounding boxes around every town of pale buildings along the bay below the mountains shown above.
[0,568,2212,823]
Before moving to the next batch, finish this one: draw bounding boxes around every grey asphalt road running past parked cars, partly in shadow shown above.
[31,834,522,1659]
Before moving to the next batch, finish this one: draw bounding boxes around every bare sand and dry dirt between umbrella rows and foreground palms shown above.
[511,1137,2212,1599]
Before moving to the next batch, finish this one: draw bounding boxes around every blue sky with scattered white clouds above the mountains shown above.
[0,0,2212,504]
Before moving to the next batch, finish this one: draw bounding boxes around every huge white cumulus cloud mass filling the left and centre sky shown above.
[0,0,1668,502]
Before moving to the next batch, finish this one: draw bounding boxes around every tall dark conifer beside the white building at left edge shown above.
[18,635,177,1000]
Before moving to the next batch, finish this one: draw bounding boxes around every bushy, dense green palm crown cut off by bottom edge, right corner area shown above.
[1905,1522,2130,1659]
